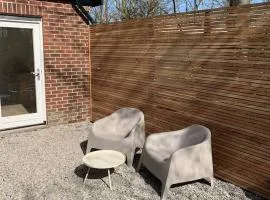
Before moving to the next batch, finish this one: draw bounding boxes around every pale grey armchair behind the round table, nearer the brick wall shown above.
[86,108,145,166]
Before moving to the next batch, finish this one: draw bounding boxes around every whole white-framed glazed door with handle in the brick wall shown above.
[0,16,46,130]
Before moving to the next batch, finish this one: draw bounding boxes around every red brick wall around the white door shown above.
[0,0,91,124]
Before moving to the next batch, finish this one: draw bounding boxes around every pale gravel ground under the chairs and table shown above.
[0,124,263,200]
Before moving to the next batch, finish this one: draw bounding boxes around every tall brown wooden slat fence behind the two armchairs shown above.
[90,3,270,197]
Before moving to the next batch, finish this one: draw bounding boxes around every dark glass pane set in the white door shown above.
[0,27,37,117]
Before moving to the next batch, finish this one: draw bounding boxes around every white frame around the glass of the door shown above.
[0,15,47,130]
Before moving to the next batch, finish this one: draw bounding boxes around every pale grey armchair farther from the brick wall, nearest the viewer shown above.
[137,125,213,200]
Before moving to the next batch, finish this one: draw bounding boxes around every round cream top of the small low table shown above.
[83,150,126,169]
